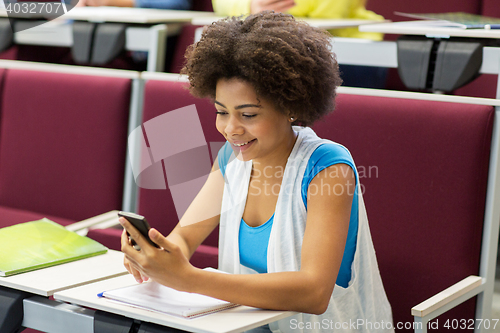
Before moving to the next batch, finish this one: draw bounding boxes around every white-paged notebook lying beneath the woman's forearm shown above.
[98,272,238,318]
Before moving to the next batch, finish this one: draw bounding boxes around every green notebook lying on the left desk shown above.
[0,218,108,276]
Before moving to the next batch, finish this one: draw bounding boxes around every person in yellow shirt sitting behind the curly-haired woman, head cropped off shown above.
[212,0,387,89]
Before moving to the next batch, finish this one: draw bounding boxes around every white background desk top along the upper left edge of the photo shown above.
[0,6,214,24]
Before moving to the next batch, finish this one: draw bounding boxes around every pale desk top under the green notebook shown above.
[0,250,128,296]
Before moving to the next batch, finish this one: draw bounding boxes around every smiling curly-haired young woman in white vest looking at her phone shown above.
[120,12,393,332]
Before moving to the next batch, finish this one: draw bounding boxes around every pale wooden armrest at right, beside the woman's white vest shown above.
[411,275,484,317]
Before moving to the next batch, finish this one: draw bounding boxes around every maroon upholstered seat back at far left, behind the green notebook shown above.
[0,69,131,226]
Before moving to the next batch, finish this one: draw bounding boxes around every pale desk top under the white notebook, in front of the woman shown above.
[54,275,295,333]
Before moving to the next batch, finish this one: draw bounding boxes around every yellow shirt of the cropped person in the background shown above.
[212,0,384,41]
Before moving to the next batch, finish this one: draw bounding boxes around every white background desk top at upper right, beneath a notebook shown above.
[359,20,500,38]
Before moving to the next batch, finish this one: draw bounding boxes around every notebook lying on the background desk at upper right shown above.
[394,12,500,29]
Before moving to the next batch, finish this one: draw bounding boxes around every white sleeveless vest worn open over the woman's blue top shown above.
[219,126,394,333]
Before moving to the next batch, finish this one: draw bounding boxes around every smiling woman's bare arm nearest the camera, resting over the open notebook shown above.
[122,164,355,314]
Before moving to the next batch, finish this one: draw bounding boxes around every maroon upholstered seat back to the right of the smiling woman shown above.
[314,94,493,329]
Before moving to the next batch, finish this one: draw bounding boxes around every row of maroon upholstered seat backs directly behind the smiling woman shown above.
[0,60,496,330]
